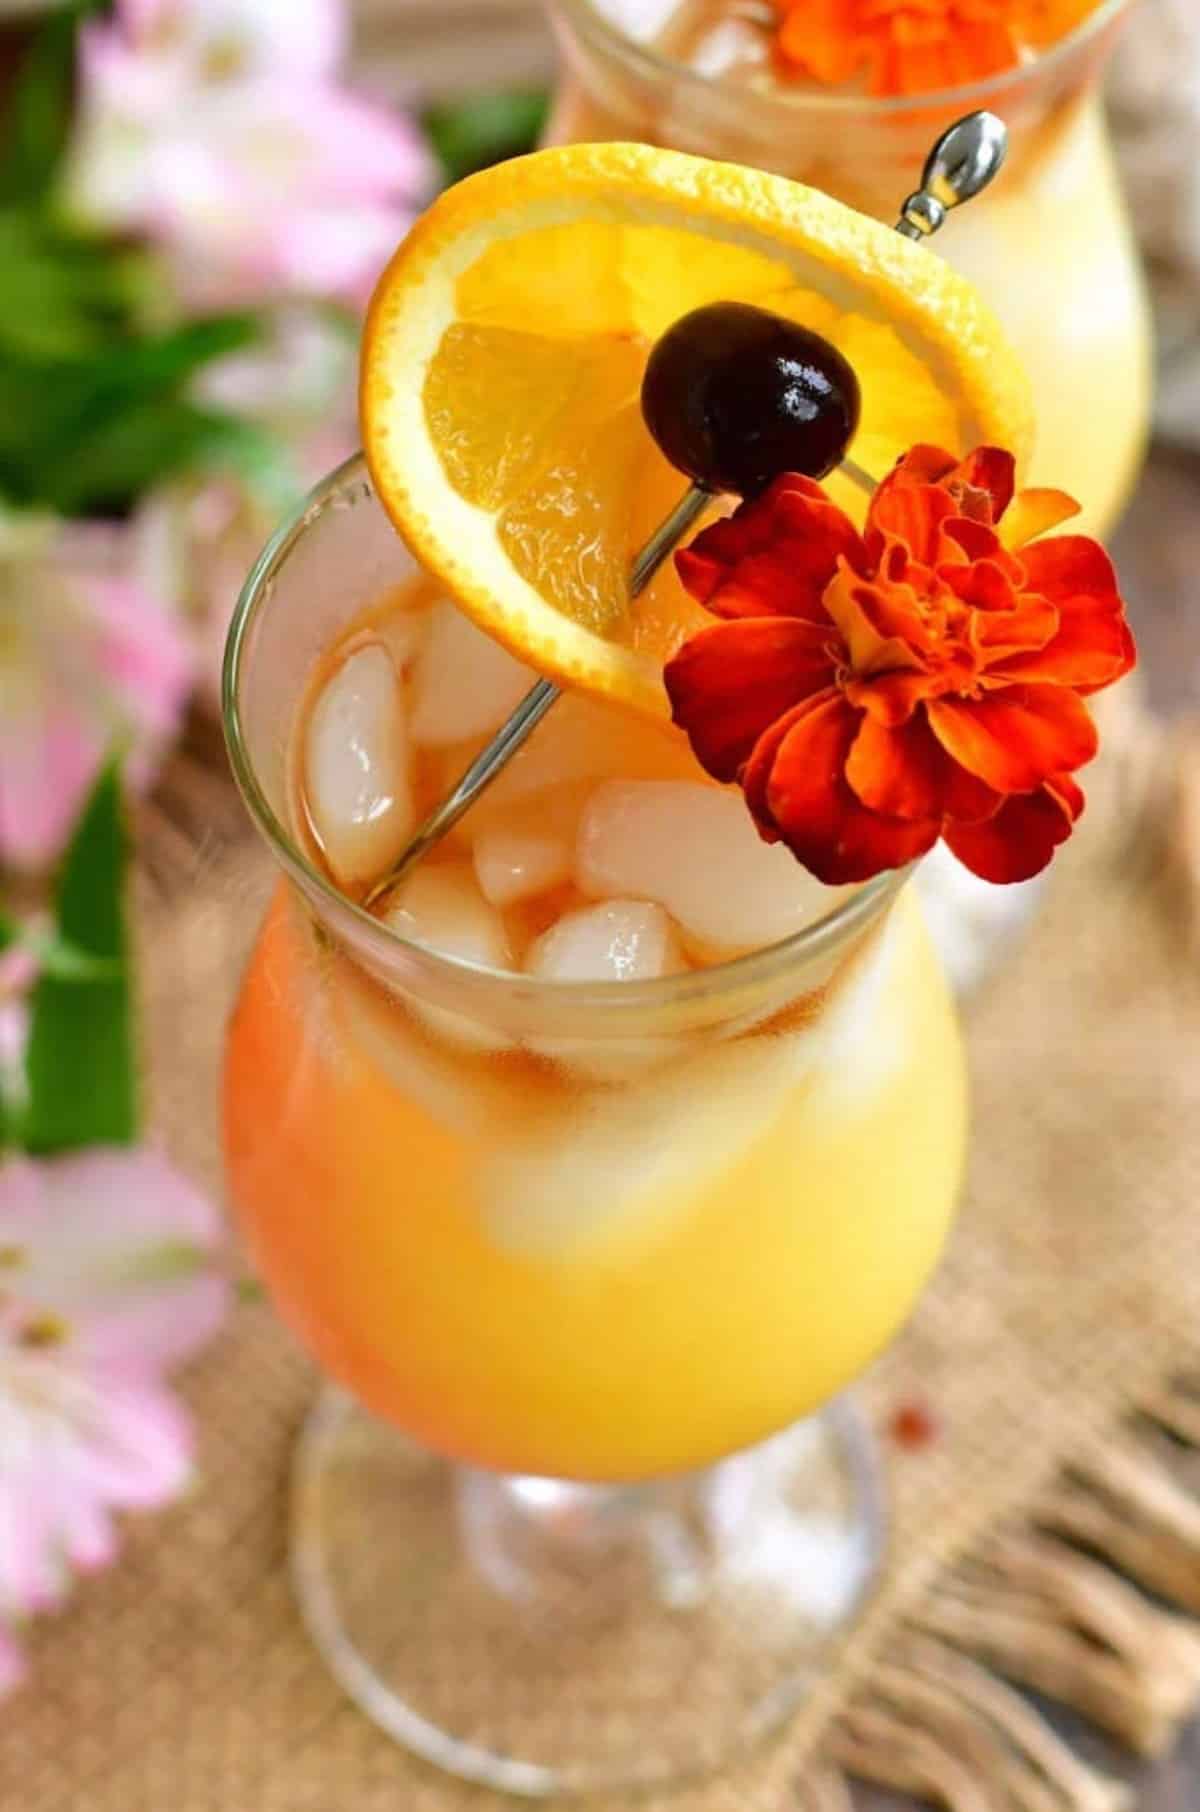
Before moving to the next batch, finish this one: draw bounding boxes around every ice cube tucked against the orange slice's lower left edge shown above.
[413,598,537,748]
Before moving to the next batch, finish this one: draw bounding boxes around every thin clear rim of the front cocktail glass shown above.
[221,453,917,1009]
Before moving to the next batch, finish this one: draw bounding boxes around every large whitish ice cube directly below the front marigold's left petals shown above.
[575,781,843,955]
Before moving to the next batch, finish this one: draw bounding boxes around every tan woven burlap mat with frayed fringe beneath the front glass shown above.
[0,701,1200,1812]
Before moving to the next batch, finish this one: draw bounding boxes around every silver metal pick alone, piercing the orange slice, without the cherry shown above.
[364,112,1008,906]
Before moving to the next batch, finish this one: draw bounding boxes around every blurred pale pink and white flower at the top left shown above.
[69,0,433,306]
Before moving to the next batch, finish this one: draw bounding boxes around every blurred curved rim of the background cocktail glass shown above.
[551,0,1133,120]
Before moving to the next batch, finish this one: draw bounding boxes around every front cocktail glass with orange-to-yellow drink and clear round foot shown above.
[225,462,964,1796]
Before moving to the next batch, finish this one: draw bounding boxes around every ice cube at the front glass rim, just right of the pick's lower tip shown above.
[384,863,513,1051]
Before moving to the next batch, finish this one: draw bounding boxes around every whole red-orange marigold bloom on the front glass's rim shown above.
[665,448,1135,886]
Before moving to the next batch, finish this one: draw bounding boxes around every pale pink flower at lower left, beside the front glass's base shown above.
[0,1149,228,1691]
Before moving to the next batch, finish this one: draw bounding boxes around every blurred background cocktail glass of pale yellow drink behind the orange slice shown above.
[547,0,1151,536]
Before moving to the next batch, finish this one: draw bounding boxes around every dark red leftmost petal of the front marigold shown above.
[663,616,834,781]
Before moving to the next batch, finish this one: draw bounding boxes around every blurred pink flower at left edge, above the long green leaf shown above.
[0,518,192,868]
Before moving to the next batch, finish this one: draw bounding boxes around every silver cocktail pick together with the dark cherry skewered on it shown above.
[366,112,1008,906]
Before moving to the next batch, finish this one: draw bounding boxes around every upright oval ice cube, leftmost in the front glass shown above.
[305,641,413,886]
